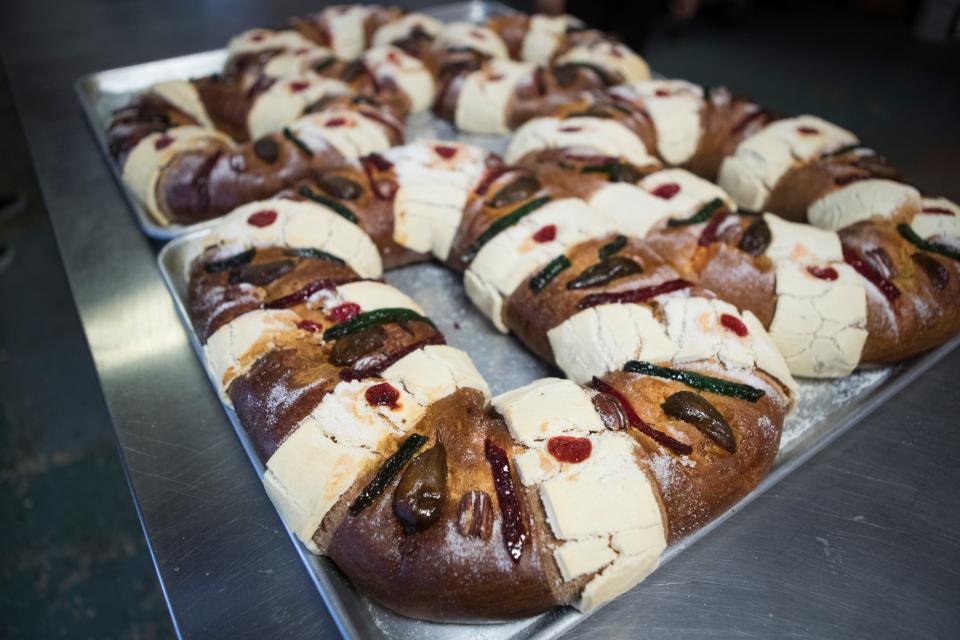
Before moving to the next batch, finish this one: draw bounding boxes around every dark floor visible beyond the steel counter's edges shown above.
[0,3,960,640]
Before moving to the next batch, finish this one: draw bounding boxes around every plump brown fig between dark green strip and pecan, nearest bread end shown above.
[393,442,447,533]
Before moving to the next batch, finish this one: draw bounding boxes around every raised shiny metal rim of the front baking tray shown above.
[157,221,960,640]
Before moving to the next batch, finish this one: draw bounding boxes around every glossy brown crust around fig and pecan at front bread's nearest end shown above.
[327,389,557,622]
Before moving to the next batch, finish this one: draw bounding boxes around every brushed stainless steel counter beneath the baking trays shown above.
[0,0,960,638]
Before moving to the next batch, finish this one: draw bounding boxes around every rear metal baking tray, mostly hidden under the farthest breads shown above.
[74,0,516,240]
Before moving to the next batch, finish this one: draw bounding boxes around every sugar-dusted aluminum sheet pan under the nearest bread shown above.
[158,229,960,640]
